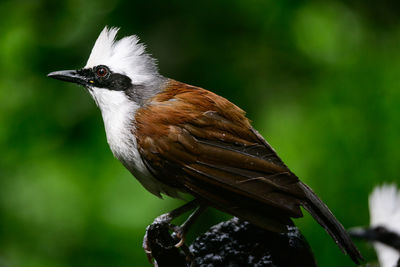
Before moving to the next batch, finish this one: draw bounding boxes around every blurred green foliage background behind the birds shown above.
[0,0,400,266]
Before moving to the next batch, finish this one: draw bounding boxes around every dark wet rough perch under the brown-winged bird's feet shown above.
[143,218,317,267]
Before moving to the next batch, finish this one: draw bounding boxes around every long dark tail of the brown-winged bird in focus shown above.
[300,182,364,264]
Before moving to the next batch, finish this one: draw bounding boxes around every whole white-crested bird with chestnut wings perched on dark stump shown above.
[48,26,363,264]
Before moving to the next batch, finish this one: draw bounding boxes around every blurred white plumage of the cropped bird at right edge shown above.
[369,185,400,267]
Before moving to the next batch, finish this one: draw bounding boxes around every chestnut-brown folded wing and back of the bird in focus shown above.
[136,81,303,230]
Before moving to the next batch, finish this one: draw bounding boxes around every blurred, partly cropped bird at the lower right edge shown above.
[349,184,400,267]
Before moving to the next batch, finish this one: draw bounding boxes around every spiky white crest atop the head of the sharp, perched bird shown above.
[85,26,158,83]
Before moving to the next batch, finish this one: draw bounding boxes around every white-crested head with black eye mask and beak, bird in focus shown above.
[48,27,164,110]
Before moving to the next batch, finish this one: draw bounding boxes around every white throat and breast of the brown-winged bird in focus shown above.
[89,88,177,197]
